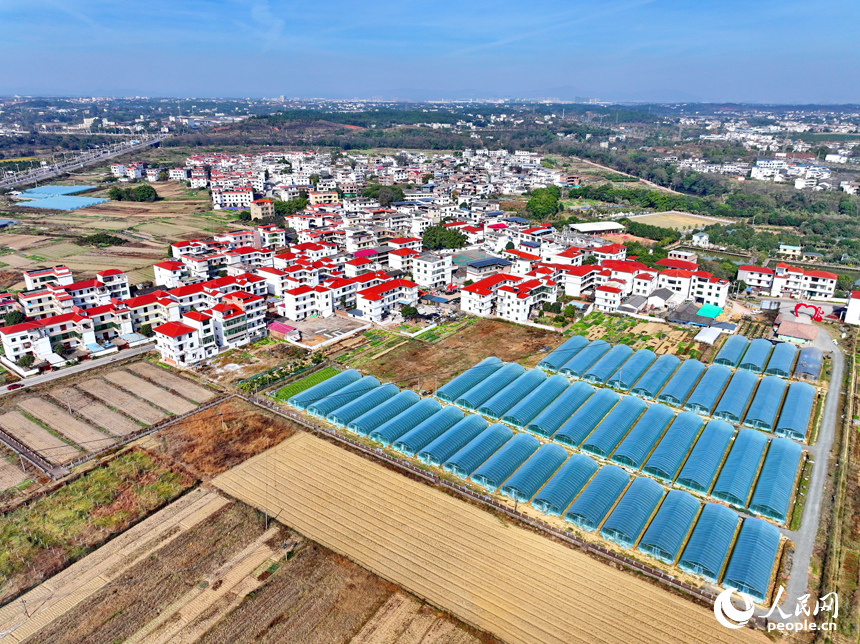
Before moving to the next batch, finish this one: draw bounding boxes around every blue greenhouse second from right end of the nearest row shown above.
[678,503,740,584]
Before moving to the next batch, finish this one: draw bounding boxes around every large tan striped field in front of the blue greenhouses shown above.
[214,433,766,644]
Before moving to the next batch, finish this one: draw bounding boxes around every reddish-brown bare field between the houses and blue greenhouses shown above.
[352,319,561,384]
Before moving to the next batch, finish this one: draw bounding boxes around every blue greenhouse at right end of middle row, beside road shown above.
[749,438,803,523]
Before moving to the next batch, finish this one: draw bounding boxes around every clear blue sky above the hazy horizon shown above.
[0,0,860,103]
